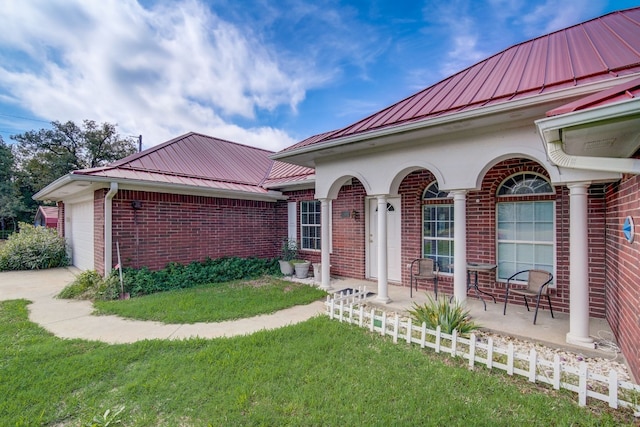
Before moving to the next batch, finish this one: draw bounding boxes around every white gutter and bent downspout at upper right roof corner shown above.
[535,98,640,174]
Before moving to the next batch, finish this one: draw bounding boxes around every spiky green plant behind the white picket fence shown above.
[409,295,479,335]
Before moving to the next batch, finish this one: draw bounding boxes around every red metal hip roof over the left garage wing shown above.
[72,132,314,193]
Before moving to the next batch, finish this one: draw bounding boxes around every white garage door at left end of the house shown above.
[65,201,95,270]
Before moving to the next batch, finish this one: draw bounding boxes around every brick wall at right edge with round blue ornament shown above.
[600,176,640,379]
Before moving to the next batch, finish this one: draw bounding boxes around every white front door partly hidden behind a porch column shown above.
[367,197,402,282]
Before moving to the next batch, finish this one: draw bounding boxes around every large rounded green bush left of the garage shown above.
[0,222,69,271]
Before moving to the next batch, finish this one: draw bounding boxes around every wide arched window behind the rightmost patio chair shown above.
[496,172,555,280]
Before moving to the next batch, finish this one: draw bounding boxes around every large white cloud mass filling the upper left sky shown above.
[0,0,312,150]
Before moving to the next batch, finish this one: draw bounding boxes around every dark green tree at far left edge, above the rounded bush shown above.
[0,136,28,231]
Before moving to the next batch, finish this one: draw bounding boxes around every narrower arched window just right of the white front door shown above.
[422,181,453,273]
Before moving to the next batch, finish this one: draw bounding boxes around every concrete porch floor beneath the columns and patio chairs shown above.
[318,277,626,363]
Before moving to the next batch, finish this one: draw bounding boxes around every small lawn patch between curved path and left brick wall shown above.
[94,276,327,323]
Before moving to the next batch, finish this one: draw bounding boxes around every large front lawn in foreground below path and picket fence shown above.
[0,300,633,426]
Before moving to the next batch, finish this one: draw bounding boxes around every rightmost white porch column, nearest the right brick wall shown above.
[567,182,595,348]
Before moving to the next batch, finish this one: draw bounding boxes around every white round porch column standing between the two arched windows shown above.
[450,190,467,304]
